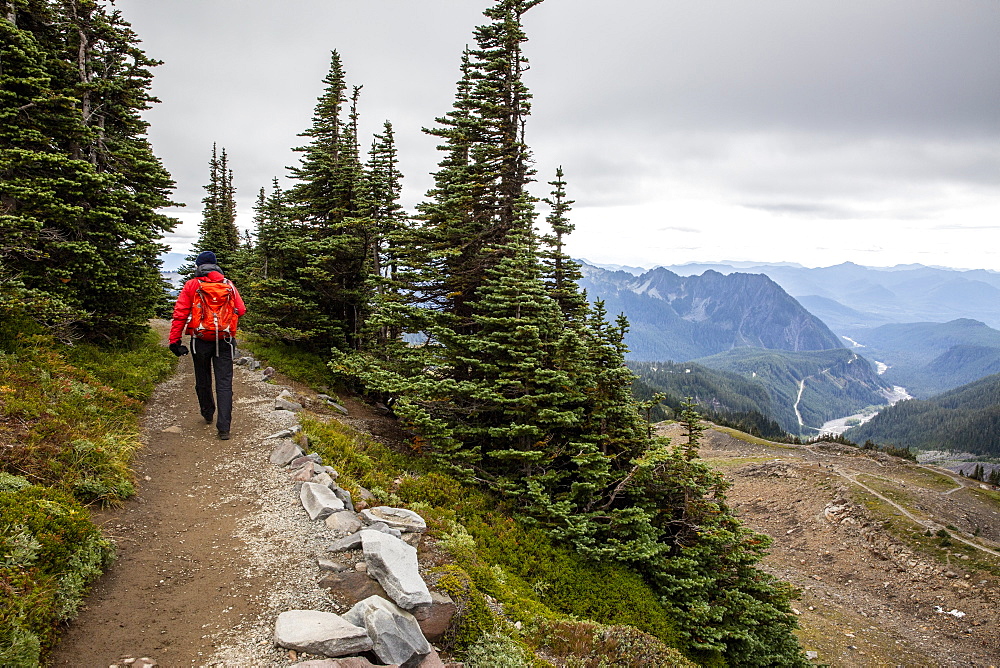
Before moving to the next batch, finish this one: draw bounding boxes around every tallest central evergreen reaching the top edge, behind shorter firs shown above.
[418,0,541,331]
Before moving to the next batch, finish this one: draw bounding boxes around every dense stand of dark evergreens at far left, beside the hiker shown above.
[0,0,175,340]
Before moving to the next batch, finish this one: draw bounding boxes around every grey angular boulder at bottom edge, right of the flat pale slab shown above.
[344,596,431,668]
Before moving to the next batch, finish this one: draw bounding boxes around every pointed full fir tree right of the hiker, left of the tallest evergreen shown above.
[254,51,373,351]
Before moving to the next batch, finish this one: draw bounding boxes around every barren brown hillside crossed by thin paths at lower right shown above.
[661,425,1000,666]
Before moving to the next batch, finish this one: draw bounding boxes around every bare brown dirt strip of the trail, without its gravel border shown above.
[49,323,292,667]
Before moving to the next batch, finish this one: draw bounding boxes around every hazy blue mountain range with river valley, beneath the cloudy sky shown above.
[581,263,1000,445]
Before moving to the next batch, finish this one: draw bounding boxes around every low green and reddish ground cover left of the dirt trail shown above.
[0,321,175,666]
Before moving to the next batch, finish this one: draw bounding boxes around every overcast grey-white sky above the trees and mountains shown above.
[116,0,1000,271]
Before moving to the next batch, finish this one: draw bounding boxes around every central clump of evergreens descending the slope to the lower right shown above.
[332,0,805,665]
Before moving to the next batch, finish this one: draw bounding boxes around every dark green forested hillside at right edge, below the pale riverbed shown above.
[844,374,1000,457]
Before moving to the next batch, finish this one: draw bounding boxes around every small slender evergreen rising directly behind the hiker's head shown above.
[181,144,240,273]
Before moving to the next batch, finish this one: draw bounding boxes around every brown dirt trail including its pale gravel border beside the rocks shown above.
[48,323,344,668]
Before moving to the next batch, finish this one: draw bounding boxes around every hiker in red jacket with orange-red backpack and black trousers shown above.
[168,251,247,440]
